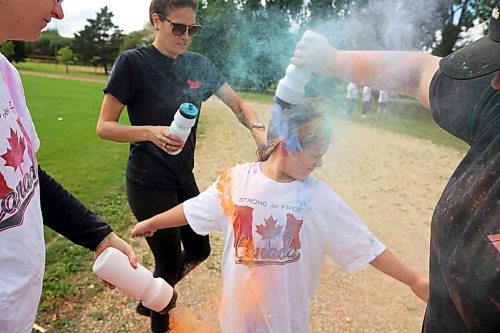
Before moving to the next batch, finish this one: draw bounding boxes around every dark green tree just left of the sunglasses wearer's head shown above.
[73,6,123,74]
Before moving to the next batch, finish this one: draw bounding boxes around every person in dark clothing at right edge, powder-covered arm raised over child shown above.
[291,0,500,333]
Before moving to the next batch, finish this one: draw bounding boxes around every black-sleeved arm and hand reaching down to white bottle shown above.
[38,166,137,267]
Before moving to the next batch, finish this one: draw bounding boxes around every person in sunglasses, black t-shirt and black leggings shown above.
[97,0,266,333]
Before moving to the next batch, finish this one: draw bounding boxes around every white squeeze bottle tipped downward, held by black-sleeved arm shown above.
[92,247,177,313]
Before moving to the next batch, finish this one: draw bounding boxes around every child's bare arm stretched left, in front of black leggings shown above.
[132,204,188,237]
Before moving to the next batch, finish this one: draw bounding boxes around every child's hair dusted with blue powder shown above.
[257,103,333,161]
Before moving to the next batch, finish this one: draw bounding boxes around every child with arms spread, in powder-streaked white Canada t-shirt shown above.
[132,104,429,333]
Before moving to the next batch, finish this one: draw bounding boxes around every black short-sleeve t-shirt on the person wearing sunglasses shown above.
[104,45,225,190]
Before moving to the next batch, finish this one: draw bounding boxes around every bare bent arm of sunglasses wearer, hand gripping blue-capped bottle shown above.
[97,93,184,153]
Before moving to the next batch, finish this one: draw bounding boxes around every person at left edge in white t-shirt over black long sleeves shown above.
[0,0,137,333]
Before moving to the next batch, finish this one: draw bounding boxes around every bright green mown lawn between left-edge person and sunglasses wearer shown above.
[23,75,128,202]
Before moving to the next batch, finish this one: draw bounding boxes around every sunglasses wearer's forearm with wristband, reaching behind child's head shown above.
[215,82,266,147]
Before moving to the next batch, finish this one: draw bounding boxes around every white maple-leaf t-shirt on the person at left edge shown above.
[0,54,45,333]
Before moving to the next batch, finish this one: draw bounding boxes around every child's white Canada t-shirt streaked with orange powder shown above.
[184,163,385,333]
